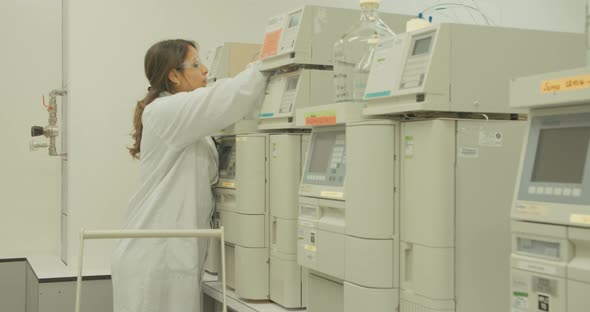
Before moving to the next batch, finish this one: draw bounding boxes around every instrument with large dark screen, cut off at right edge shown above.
[510,68,590,312]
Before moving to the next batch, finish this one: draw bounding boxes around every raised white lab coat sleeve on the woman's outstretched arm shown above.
[142,63,267,149]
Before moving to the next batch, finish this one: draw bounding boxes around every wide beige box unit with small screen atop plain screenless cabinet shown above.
[363,24,585,115]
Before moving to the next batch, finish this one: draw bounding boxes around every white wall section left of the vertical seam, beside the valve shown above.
[0,0,62,258]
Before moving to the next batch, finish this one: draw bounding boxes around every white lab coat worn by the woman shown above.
[111,64,266,312]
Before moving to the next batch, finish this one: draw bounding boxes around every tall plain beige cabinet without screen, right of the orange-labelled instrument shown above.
[399,116,526,312]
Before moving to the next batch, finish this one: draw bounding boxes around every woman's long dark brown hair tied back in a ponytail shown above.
[129,39,198,159]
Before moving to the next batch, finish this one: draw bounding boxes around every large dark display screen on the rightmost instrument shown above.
[531,127,590,184]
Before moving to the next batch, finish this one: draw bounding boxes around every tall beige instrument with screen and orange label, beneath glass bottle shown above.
[297,103,399,312]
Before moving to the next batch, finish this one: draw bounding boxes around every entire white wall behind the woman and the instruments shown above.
[0,0,585,271]
